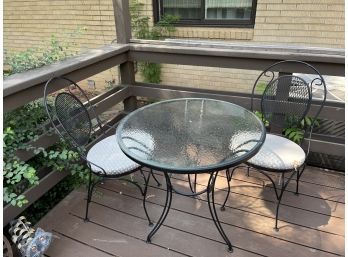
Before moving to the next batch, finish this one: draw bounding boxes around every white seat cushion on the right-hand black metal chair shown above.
[247,134,306,170]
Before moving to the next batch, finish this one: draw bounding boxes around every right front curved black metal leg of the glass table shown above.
[207,171,233,252]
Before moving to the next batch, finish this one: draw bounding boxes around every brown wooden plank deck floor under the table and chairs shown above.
[38,167,345,257]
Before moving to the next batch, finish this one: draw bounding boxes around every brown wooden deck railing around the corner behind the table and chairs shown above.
[3,41,345,226]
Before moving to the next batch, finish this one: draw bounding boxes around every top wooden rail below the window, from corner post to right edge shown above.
[130,40,345,76]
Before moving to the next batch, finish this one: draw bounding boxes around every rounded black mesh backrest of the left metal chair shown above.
[44,77,101,151]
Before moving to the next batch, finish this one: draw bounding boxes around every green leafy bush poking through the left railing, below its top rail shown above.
[3,101,87,207]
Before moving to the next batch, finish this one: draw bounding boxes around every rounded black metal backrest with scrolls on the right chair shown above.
[251,60,327,133]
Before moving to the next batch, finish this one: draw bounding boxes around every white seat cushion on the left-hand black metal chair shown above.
[87,135,140,175]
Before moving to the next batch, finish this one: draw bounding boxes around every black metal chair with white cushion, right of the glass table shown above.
[221,60,327,231]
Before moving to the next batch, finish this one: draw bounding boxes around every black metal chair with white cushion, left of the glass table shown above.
[44,77,160,225]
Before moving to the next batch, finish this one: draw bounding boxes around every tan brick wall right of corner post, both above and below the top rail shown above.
[137,0,344,92]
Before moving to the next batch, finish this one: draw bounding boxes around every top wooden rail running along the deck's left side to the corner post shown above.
[3,45,129,112]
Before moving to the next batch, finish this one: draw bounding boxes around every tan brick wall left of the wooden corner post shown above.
[3,0,118,90]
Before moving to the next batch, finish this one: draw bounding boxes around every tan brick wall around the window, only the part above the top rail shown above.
[142,0,344,48]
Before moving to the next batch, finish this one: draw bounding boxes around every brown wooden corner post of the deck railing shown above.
[112,0,137,112]
